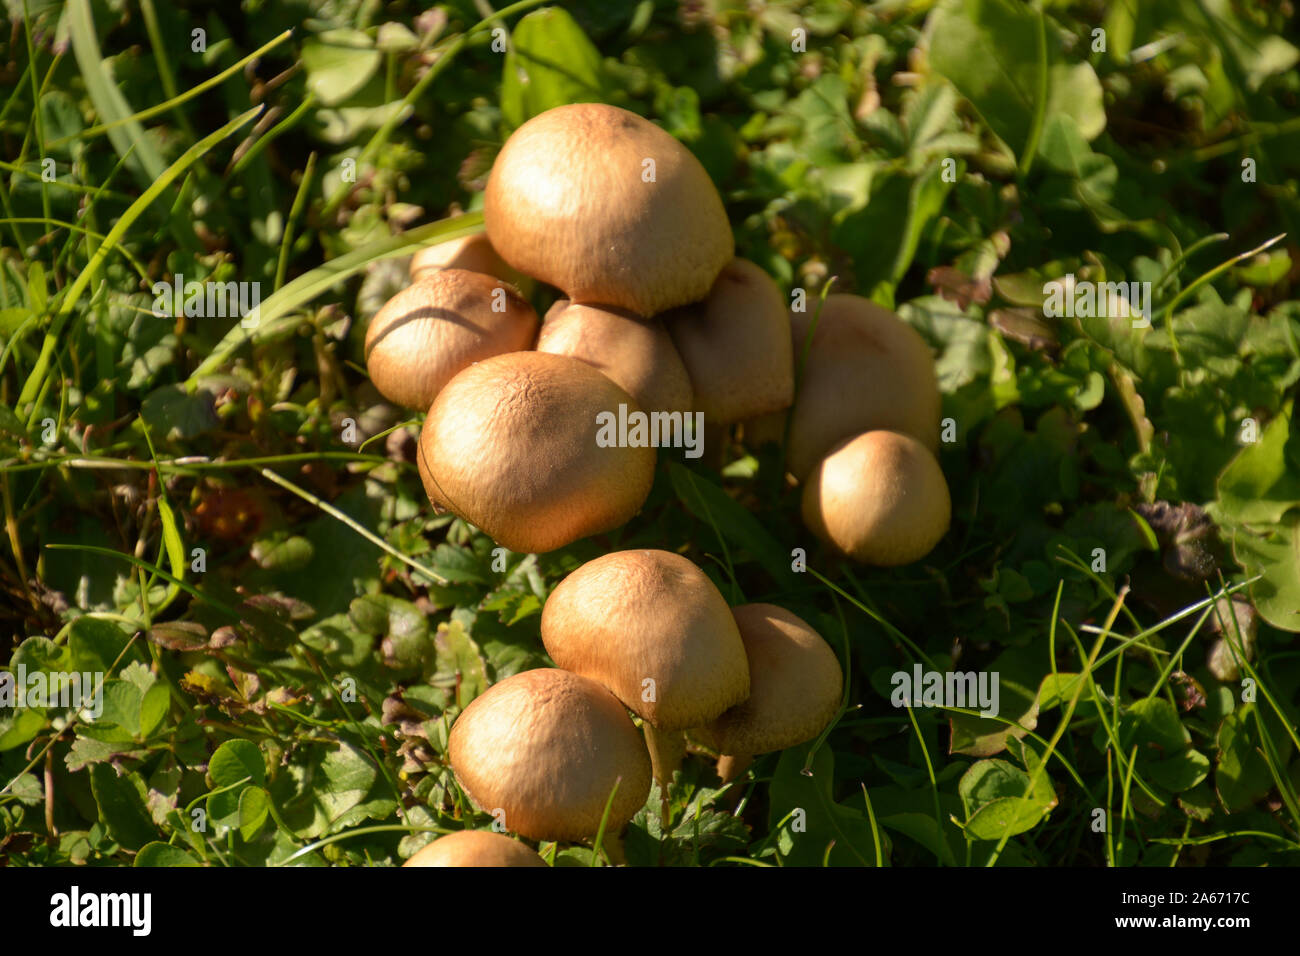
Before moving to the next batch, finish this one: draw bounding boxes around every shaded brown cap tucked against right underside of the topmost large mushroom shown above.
[664,259,794,424]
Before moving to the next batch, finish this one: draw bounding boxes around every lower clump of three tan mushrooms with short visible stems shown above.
[436,550,844,865]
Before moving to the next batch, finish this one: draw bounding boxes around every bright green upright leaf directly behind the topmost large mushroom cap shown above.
[501,7,605,127]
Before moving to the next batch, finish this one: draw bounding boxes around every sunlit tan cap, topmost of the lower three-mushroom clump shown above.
[542,550,749,731]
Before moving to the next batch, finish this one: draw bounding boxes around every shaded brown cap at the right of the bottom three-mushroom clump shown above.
[701,604,844,754]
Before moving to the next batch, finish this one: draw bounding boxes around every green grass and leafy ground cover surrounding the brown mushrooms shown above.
[0,0,1300,866]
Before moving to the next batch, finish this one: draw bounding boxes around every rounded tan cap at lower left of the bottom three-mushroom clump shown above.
[447,667,650,840]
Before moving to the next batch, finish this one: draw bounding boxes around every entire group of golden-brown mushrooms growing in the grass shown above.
[365,104,950,865]
